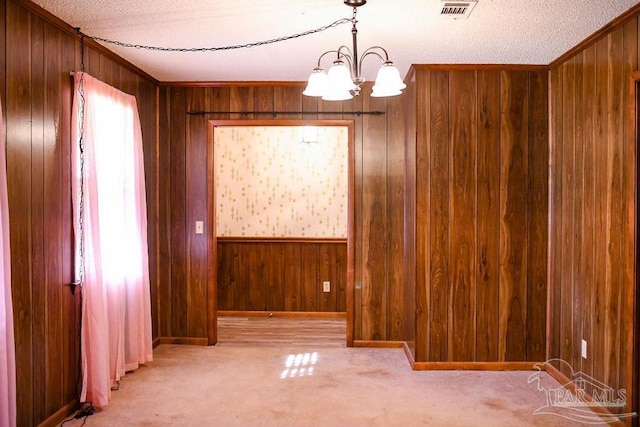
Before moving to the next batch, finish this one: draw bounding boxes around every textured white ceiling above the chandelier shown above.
[33,0,640,81]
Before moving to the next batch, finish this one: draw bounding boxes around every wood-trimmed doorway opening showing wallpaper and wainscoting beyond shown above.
[206,120,355,346]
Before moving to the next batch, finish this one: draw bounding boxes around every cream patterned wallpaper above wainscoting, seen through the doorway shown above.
[214,126,348,238]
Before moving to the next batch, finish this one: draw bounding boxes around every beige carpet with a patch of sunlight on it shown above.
[60,345,608,426]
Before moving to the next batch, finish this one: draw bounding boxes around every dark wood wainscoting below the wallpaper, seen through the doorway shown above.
[217,237,347,312]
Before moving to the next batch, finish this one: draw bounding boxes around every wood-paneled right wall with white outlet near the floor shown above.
[549,16,640,412]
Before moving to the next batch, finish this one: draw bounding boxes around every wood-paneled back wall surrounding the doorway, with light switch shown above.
[158,83,405,340]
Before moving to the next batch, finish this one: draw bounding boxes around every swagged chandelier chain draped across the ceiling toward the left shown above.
[76,16,356,52]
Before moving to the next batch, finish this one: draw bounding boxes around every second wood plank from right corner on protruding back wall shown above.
[499,71,528,361]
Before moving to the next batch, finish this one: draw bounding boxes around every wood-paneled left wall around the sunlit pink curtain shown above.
[0,0,157,426]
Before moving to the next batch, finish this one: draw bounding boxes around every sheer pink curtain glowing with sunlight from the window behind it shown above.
[72,72,153,407]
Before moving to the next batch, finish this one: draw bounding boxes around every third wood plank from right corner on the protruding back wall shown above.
[476,70,500,362]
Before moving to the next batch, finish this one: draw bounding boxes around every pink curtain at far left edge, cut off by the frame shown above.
[0,99,16,426]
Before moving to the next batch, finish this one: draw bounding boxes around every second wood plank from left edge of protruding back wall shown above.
[426,71,450,362]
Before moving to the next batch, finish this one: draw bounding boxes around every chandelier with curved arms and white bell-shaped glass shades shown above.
[302,0,407,101]
